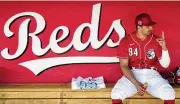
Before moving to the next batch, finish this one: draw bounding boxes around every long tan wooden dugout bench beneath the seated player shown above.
[0,83,180,104]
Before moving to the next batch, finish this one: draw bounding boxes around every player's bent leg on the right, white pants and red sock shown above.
[147,70,175,104]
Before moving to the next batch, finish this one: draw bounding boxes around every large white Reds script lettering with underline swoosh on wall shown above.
[0,3,125,75]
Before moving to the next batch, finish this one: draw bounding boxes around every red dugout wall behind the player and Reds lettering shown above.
[0,1,180,82]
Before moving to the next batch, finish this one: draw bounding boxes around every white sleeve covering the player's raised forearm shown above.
[159,50,170,68]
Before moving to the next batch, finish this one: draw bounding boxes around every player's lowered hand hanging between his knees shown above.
[135,82,146,96]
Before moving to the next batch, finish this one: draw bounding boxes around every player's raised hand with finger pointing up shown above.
[156,31,167,50]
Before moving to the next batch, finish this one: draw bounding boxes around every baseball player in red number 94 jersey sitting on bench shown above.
[111,13,175,104]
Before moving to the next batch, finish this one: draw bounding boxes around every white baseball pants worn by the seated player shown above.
[111,69,175,100]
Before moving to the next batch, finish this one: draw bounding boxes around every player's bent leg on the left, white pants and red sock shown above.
[111,76,137,104]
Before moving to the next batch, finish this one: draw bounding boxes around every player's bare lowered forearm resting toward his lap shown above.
[121,65,138,86]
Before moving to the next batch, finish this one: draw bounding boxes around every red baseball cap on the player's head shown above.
[135,13,156,26]
